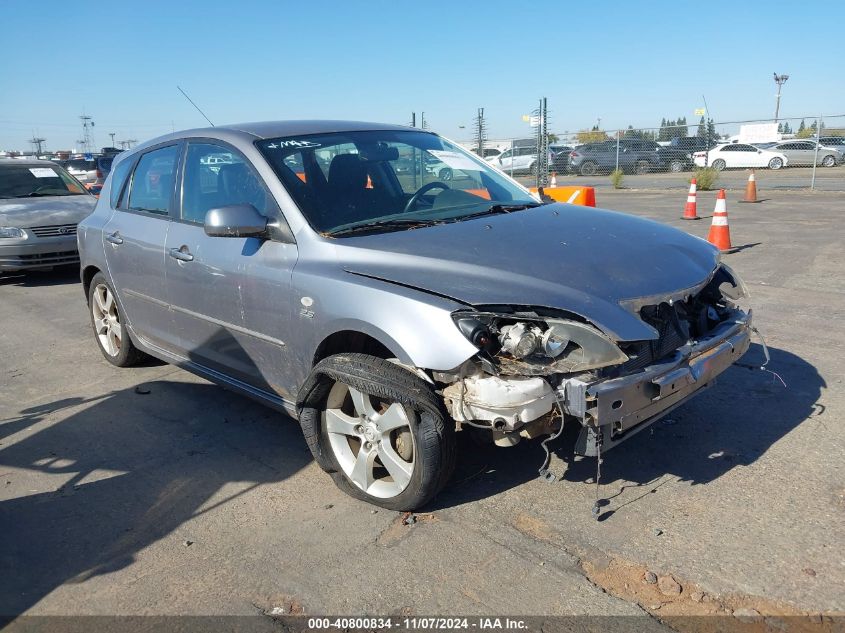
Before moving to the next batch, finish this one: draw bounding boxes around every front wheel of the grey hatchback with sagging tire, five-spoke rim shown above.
[298,354,455,511]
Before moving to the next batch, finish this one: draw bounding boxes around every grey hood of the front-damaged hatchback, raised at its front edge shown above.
[336,204,719,340]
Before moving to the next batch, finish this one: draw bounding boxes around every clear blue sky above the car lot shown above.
[0,0,845,149]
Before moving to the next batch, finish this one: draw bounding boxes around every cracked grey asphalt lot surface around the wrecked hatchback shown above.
[0,185,845,630]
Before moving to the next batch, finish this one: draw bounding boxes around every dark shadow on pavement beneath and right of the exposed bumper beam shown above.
[432,344,826,519]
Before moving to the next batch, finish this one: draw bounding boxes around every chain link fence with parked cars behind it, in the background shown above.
[464,114,845,191]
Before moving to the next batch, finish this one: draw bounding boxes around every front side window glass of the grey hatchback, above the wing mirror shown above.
[182,143,270,224]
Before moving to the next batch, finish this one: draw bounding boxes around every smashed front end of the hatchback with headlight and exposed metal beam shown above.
[434,265,751,455]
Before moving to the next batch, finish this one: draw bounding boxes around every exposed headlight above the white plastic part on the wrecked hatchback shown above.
[454,313,628,372]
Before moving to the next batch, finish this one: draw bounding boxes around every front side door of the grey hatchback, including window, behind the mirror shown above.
[165,139,297,399]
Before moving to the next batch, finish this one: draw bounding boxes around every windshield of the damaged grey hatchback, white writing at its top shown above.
[257,130,537,234]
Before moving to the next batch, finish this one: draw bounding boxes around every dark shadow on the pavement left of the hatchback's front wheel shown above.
[0,381,311,616]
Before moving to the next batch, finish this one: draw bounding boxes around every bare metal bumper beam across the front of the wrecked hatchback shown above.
[560,313,751,456]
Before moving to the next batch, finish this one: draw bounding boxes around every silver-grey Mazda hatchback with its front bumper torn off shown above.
[78,121,751,510]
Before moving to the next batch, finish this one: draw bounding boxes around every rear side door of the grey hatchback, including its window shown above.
[103,143,181,351]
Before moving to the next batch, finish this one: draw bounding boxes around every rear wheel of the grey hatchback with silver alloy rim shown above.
[88,273,144,367]
